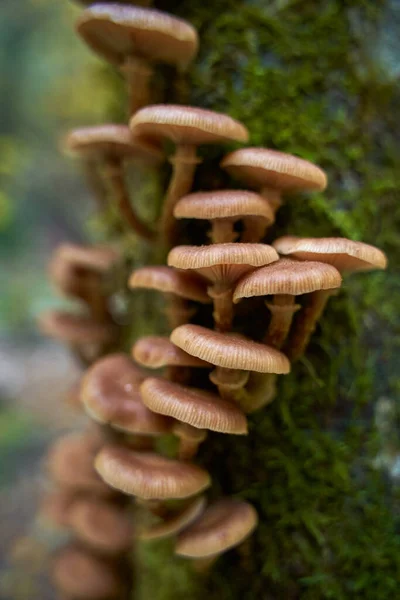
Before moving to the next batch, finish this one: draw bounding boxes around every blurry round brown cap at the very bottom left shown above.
[52,546,122,600]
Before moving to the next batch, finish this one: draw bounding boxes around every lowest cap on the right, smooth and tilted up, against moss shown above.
[175,499,258,558]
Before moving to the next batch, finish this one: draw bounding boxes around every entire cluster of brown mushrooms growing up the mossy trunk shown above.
[40,2,386,600]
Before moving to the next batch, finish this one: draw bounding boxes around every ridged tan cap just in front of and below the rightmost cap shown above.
[233,258,342,302]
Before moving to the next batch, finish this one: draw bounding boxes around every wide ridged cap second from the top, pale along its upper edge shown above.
[129,104,249,146]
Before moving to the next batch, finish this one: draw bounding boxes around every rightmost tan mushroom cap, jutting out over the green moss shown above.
[273,236,387,272]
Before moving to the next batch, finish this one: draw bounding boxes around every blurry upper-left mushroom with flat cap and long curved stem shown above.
[64,125,163,240]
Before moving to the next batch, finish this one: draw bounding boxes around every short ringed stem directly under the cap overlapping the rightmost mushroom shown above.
[264,294,300,350]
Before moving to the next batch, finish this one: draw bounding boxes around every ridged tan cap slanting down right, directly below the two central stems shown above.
[171,325,290,374]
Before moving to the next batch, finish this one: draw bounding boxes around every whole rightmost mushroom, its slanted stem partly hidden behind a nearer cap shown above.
[274,236,387,361]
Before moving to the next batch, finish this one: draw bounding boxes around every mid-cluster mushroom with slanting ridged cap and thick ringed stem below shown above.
[171,325,290,412]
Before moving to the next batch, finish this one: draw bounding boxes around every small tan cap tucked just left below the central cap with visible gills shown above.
[128,265,210,304]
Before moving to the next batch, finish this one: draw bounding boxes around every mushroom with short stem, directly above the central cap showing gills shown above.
[174,190,274,244]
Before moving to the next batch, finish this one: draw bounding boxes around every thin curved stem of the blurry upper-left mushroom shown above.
[106,160,155,241]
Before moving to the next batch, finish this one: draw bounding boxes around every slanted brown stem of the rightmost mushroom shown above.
[285,290,335,361]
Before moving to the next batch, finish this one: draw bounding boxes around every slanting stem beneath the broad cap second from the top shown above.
[161,144,201,247]
